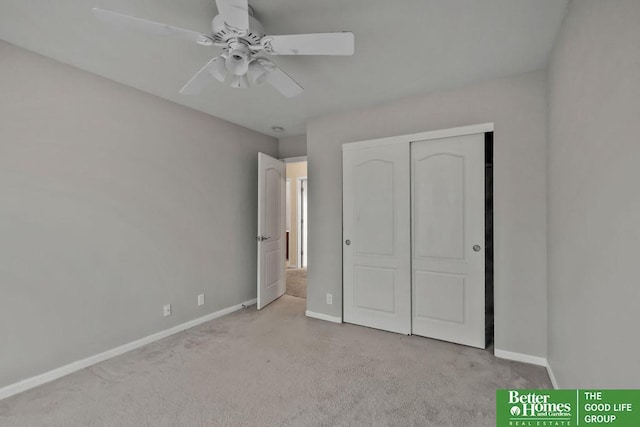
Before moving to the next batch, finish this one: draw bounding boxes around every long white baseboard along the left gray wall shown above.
[0,298,256,400]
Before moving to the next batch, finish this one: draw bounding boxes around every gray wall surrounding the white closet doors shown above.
[307,70,547,357]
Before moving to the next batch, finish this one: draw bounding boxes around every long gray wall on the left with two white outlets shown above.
[0,42,278,387]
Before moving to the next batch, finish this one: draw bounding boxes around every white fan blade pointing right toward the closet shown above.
[261,32,354,55]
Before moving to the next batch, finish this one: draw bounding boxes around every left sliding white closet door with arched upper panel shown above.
[342,143,411,334]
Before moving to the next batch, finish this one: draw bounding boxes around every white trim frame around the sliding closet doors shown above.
[339,122,497,332]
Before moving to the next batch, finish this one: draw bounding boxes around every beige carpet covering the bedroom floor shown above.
[0,295,551,427]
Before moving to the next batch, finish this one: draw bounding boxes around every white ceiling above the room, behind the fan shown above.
[0,0,567,137]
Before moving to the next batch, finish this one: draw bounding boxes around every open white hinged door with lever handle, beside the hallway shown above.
[256,153,286,310]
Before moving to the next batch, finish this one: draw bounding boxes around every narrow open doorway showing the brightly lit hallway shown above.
[284,158,308,298]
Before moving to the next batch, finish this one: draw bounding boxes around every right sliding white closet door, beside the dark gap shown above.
[411,134,485,348]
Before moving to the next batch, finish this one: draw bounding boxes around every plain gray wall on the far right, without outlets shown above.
[548,0,640,388]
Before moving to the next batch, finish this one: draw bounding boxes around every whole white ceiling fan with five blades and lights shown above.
[93,0,354,98]
